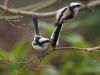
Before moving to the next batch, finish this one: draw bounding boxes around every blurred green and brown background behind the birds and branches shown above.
[0,0,100,75]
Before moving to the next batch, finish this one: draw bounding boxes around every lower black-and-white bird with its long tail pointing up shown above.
[32,16,50,51]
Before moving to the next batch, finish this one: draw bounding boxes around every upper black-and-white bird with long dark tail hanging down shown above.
[51,2,81,48]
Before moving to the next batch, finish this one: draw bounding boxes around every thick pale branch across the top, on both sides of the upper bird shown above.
[0,1,100,17]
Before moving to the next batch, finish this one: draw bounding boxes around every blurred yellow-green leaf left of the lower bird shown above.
[10,40,31,60]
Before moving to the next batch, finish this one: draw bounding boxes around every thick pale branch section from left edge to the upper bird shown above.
[0,5,56,17]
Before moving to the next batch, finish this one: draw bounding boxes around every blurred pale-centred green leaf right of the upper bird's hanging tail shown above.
[64,32,88,47]
